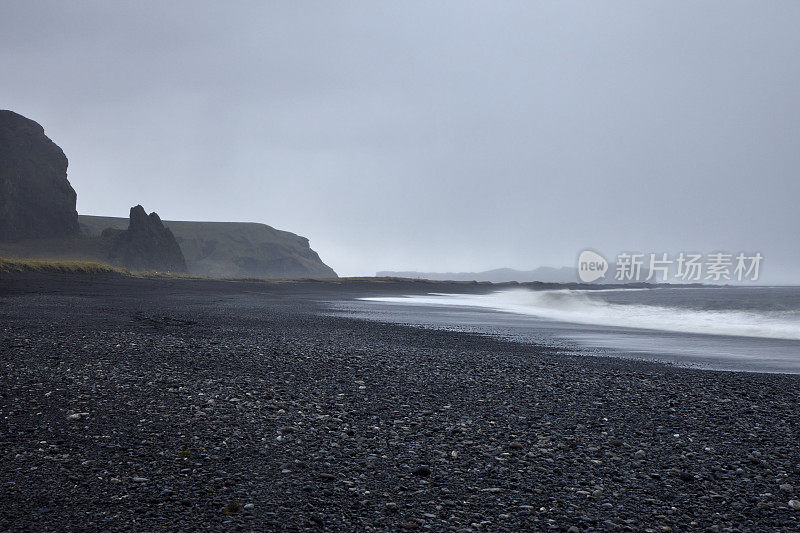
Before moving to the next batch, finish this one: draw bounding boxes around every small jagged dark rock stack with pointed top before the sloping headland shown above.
[108,205,186,272]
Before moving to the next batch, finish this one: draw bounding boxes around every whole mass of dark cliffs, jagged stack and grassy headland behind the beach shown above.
[0,111,336,278]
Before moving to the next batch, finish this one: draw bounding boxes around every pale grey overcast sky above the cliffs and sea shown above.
[0,0,800,282]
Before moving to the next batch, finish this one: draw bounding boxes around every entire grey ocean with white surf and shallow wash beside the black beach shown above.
[334,287,800,374]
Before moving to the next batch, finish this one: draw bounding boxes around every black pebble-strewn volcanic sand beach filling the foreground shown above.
[0,275,800,532]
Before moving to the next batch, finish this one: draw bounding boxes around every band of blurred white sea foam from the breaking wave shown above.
[362,289,800,340]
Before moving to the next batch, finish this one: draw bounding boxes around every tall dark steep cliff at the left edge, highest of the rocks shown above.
[0,110,78,242]
